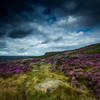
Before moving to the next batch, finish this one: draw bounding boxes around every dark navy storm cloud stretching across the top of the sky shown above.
[0,0,100,26]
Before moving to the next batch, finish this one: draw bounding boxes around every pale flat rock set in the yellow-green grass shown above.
[34,78,61,92]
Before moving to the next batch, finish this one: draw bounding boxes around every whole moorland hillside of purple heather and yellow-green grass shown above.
[0,43,100,100]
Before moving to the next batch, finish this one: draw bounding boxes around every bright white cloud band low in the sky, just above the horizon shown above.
[0,26,100,56]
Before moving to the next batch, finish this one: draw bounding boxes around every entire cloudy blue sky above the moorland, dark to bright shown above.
[0,0,100,56]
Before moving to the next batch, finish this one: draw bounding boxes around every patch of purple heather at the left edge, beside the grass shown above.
[0,62,32,77]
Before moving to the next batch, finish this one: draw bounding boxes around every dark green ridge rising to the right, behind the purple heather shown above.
[40,43,100,57]
